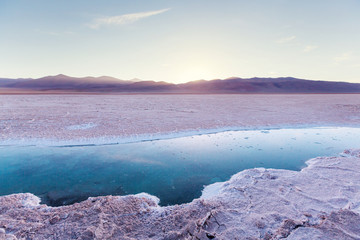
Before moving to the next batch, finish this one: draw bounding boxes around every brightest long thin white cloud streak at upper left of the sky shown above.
[89,8,170,29]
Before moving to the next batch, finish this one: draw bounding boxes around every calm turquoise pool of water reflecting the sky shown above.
[0,128,360,206]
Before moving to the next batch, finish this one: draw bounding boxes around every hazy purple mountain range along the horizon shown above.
[0,74,360,93]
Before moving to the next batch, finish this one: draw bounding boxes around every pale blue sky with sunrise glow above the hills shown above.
[0,0,360,83]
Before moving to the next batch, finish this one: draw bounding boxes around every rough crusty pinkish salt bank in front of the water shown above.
[0,150,360,240]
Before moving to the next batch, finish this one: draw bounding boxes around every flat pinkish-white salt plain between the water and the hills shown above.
[0,94,360,141]
